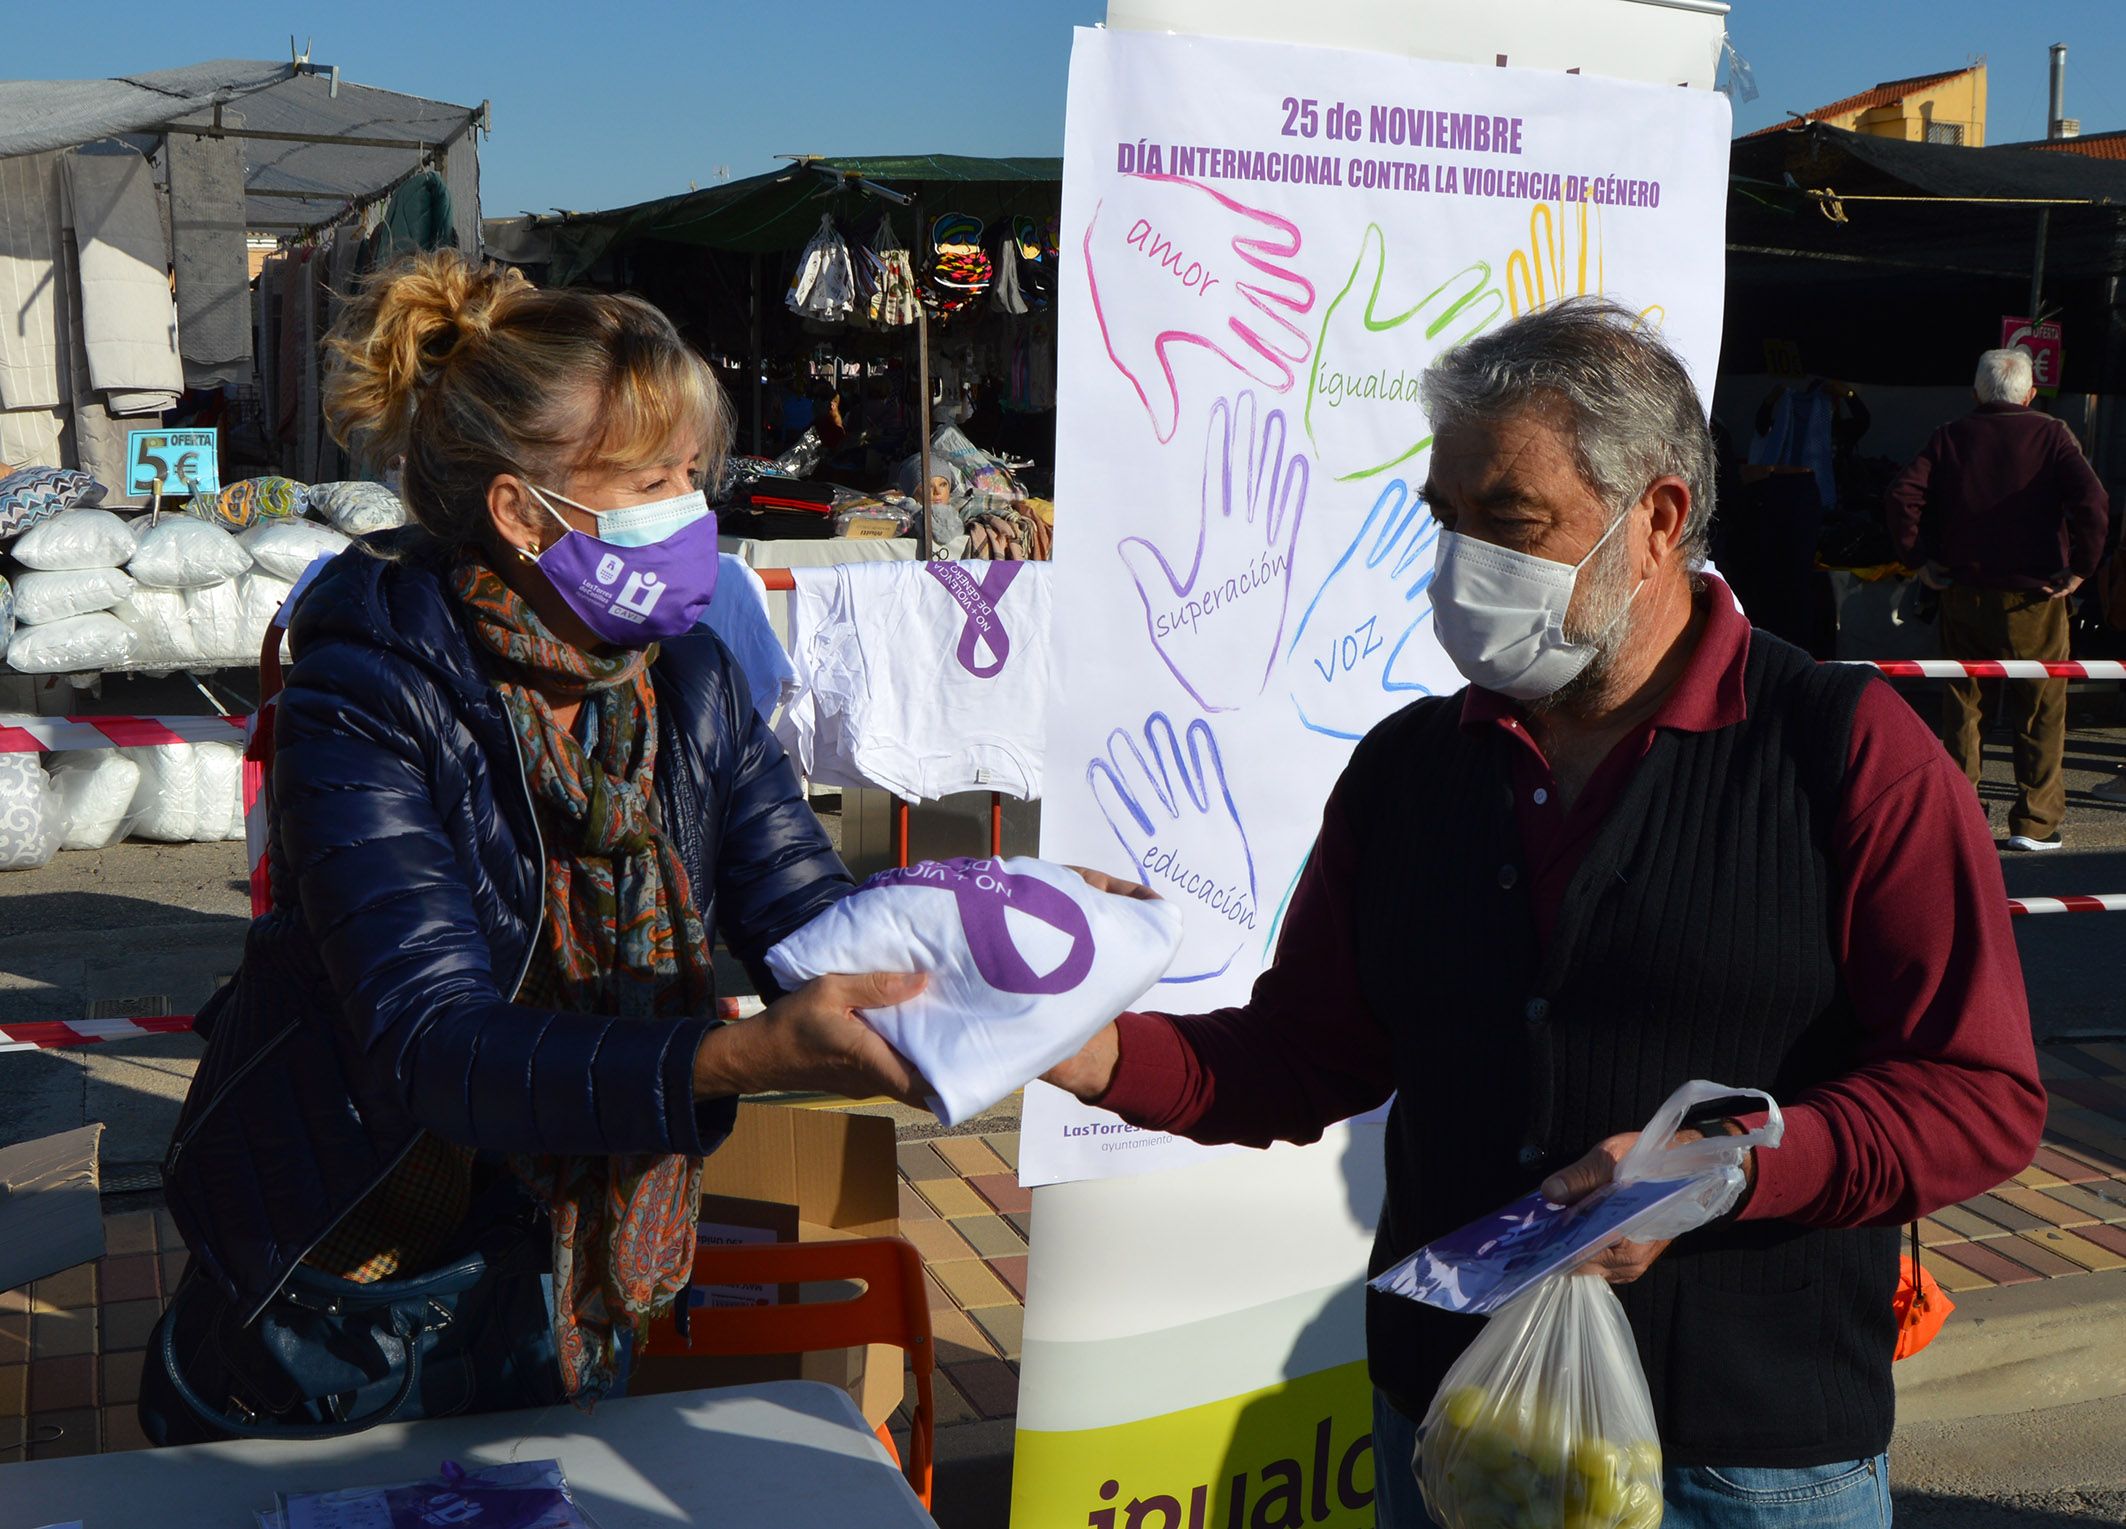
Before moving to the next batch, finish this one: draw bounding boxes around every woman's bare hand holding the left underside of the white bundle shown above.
[693,972,929,1108]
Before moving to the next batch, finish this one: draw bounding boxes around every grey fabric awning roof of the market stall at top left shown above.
[0,60,485,232]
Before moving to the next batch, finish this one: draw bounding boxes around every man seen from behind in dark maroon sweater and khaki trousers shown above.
[1884,351,2109,851]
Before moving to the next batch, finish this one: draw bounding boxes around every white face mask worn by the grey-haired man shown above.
[1433,510,1646,702]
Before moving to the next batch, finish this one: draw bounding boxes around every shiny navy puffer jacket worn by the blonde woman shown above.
[164,532,848,1314]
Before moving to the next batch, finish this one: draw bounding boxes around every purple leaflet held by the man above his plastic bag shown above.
[1367,1178,1701,1316]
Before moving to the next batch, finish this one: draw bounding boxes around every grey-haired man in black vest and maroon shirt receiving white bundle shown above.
[1050,300,2045,1529]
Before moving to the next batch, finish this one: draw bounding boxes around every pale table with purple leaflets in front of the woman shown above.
[0,1380,931,1529]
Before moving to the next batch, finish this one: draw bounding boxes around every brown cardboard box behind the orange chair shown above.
[627,1102,906,1427]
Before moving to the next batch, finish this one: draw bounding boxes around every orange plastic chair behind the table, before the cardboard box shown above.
[644,1238,938,1508]
